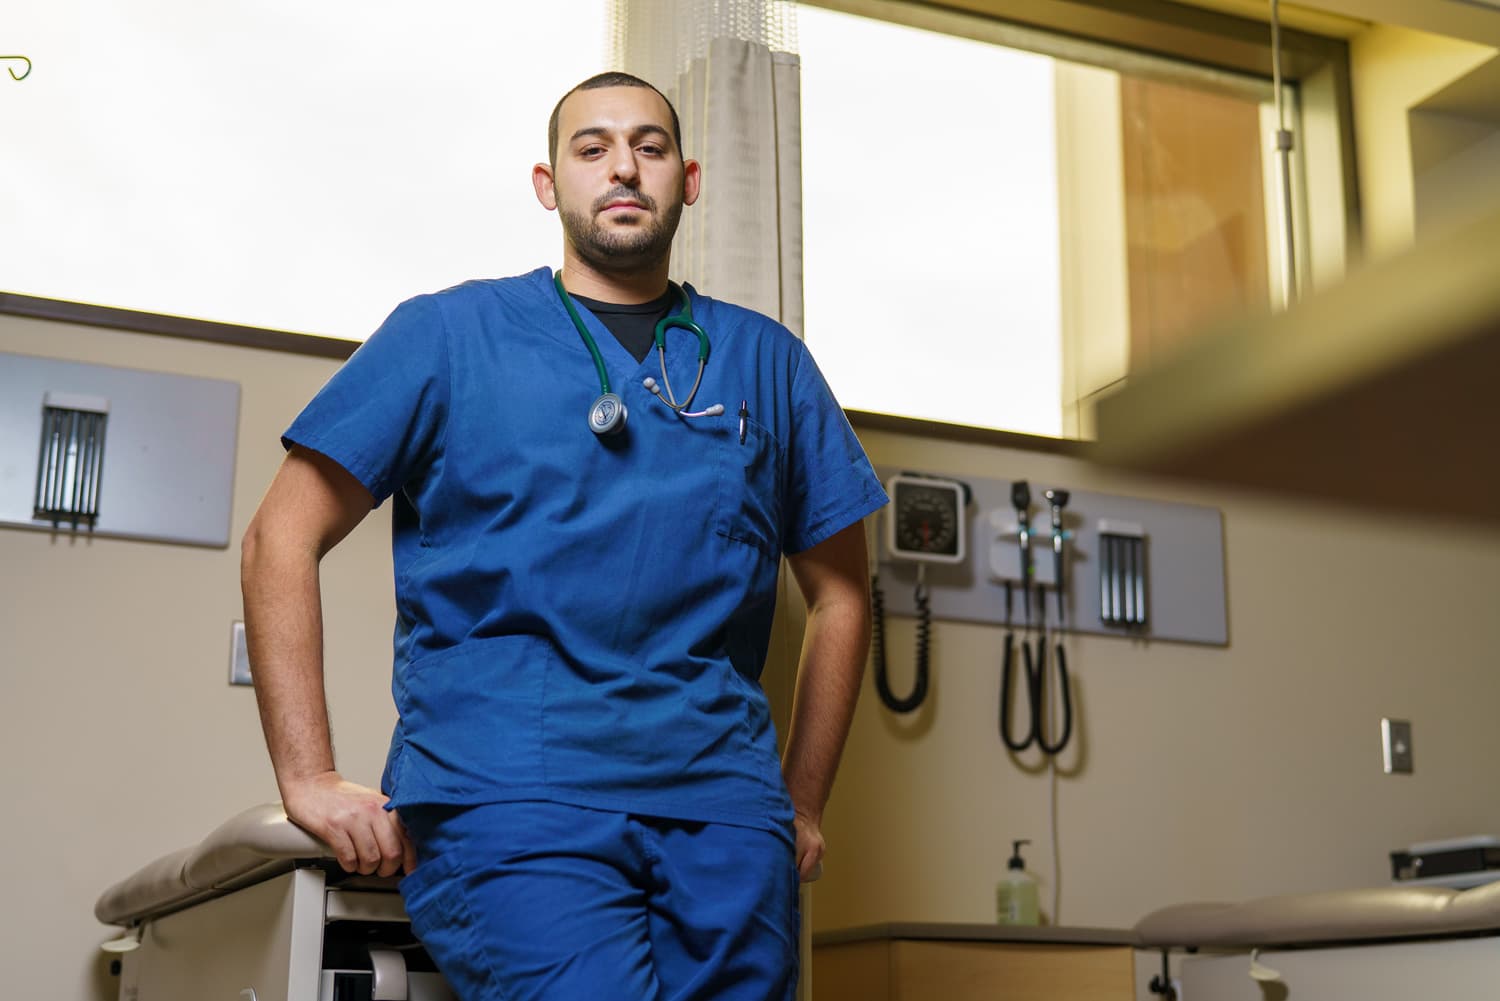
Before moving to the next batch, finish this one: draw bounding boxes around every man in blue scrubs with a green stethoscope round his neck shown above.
[242,74,885,1001]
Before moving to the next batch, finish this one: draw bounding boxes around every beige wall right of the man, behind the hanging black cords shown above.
[813,432,1500,929]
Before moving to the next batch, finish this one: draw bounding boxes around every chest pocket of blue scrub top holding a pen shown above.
[716,413,783,558]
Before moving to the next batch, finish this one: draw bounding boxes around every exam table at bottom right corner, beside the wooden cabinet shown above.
[1136,882,1500,1001]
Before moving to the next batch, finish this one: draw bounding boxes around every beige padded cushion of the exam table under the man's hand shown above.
[95,803,333,924]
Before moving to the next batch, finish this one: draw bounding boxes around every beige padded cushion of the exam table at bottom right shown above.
[1136,882,1500,948]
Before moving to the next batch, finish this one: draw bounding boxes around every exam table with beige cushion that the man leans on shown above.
[95,803,453,1001]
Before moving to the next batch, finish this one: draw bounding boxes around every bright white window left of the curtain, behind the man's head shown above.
[0,0,605,339]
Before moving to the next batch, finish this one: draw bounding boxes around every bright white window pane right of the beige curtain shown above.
[797,6,1061,435]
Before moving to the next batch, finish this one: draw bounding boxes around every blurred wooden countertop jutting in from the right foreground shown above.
[1095,198,1500,527]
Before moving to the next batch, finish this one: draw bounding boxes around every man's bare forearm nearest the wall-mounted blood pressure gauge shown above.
[782,596,870,821]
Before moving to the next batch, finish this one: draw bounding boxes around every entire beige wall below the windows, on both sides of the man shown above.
[11,317,1500,1001]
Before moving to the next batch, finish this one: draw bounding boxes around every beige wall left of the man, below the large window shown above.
[0,315,395,1001]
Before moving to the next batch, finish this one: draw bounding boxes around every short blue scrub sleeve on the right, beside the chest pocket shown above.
[785,344,888,554]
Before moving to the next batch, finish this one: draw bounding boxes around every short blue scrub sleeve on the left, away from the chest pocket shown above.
[282,296,449,504]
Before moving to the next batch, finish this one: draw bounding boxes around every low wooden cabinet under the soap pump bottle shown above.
[812,924,1136,1001]
